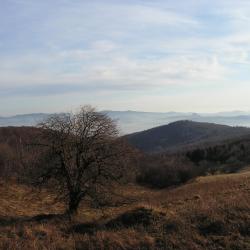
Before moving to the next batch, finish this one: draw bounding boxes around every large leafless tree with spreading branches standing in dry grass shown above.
[33,106,131,215]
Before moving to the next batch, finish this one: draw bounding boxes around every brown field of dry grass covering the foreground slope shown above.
[0,171,250,250]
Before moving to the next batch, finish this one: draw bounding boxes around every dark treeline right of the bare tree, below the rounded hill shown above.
[137,138,250,188]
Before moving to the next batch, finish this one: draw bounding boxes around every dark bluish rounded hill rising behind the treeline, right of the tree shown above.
[126,121,250,152]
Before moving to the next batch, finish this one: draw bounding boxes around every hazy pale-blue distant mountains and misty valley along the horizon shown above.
[0,110,250,135]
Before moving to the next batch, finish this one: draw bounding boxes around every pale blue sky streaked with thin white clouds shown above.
[0,0,250,116]
